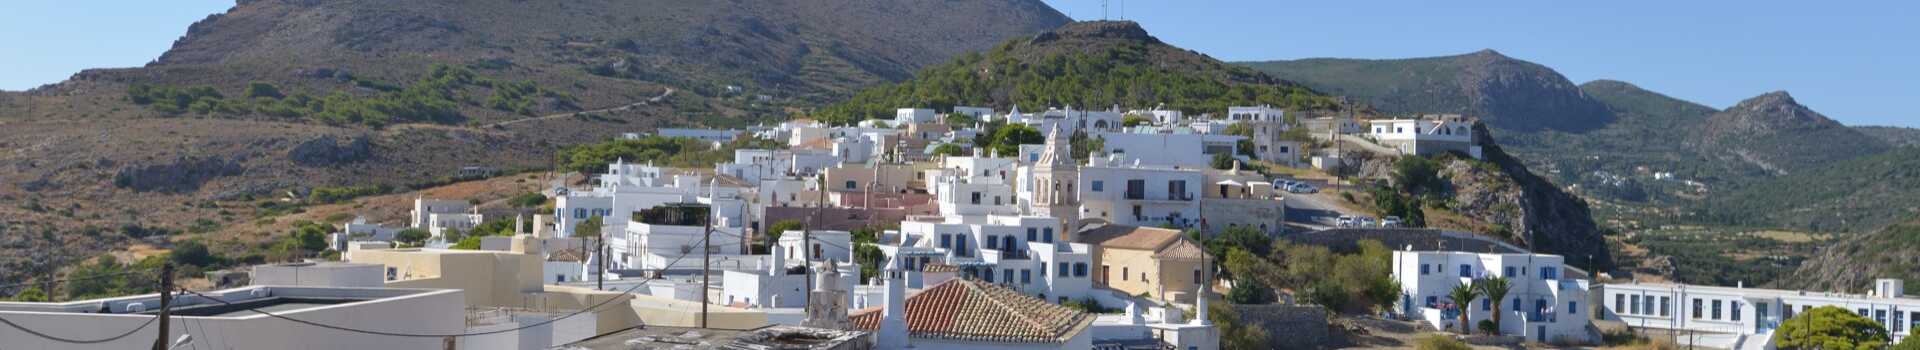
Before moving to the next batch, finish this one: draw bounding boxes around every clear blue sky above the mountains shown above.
[0,0,1920,127]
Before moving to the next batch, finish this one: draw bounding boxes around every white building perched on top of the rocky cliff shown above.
[1367,115,1480,160]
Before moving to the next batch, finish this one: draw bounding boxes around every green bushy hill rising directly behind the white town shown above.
[818,21,1336,121]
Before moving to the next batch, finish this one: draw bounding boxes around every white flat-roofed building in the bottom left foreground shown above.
[0,287,464,350]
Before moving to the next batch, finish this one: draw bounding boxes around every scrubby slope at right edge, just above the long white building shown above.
[1774,221,1920,294]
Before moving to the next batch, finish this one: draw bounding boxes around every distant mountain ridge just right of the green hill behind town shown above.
[1240,50,1615,133]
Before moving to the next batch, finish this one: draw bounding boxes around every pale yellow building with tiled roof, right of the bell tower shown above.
[1077,225,1208,302]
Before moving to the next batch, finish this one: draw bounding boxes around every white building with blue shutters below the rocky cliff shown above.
[1394,250,1597,342]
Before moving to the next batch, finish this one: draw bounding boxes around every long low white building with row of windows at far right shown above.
[1596,279,1920,348]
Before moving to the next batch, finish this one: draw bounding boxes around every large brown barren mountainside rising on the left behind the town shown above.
[0,0,1069,281]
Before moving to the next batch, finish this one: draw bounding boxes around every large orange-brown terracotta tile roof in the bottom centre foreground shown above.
[852,279,1094,344]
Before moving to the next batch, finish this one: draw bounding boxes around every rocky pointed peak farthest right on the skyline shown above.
[1695,90,1889,173]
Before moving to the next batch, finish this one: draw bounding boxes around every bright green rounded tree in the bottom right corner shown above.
[1774,306,1912,350]
